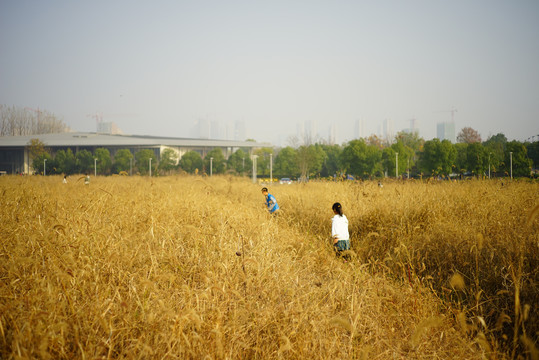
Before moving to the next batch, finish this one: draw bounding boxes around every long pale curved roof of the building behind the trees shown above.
[0,132,272,148]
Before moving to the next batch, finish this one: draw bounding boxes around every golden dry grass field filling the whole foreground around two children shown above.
[0,176,539,359]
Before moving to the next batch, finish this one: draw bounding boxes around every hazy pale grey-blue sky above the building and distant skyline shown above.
[0,0,539,145]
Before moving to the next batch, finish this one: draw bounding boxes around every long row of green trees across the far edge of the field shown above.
[30,132,539,179]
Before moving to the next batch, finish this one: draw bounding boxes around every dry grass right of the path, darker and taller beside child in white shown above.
[281,181,539,358]
